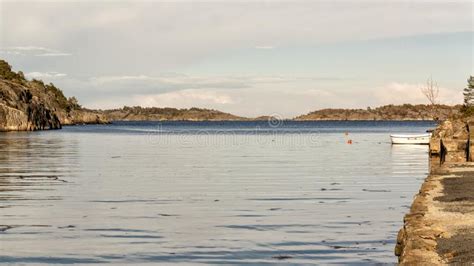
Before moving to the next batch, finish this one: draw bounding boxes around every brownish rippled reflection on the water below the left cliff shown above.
[0,133,75,205]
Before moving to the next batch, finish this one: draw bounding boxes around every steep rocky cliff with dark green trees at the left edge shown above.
[0,60,107,131]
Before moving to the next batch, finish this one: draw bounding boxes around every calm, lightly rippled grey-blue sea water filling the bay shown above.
[0,121,434,264]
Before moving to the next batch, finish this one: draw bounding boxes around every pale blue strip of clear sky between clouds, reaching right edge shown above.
[187,32,473,82]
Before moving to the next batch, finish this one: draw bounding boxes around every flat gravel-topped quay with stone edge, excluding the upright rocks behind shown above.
[395,163,474,265]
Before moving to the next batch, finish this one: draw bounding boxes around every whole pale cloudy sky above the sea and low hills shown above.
[0,0,474,117]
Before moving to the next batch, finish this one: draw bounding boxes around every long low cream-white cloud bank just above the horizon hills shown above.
[73,76,462,118]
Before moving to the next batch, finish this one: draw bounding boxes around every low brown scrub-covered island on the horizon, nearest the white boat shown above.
[295,104,461,120]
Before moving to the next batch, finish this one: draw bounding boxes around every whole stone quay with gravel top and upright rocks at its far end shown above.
[395,121,474,265]
